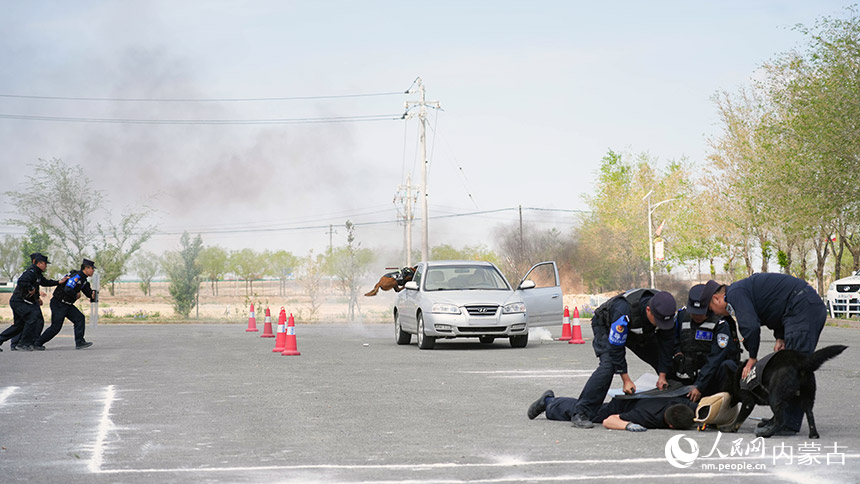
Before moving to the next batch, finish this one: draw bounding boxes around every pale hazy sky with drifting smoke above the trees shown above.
[0,0,852,262]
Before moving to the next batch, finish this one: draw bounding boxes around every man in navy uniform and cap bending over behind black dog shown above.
[704,273,827,433]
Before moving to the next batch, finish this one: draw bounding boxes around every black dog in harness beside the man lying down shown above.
[725,345,848,439]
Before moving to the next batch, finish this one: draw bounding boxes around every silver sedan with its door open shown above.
[394,261,562,349]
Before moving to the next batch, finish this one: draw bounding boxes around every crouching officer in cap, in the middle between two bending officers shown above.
[672,284,740,402]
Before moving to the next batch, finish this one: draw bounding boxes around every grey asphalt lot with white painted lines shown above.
[0,321,860,483]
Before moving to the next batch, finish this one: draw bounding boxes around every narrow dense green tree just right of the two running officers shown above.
[163,232,203,318]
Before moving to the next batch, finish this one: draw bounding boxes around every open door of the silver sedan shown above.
[517,261,564,326]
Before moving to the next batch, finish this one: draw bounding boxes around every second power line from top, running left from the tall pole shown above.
[0,113,401,125]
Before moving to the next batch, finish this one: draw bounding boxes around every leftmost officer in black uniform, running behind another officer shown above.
[0,252,66,351]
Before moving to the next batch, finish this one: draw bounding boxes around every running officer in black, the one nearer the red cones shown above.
[33,259,96,351]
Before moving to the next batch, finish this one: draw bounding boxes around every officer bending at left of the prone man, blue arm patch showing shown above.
[571,289,677,428]
